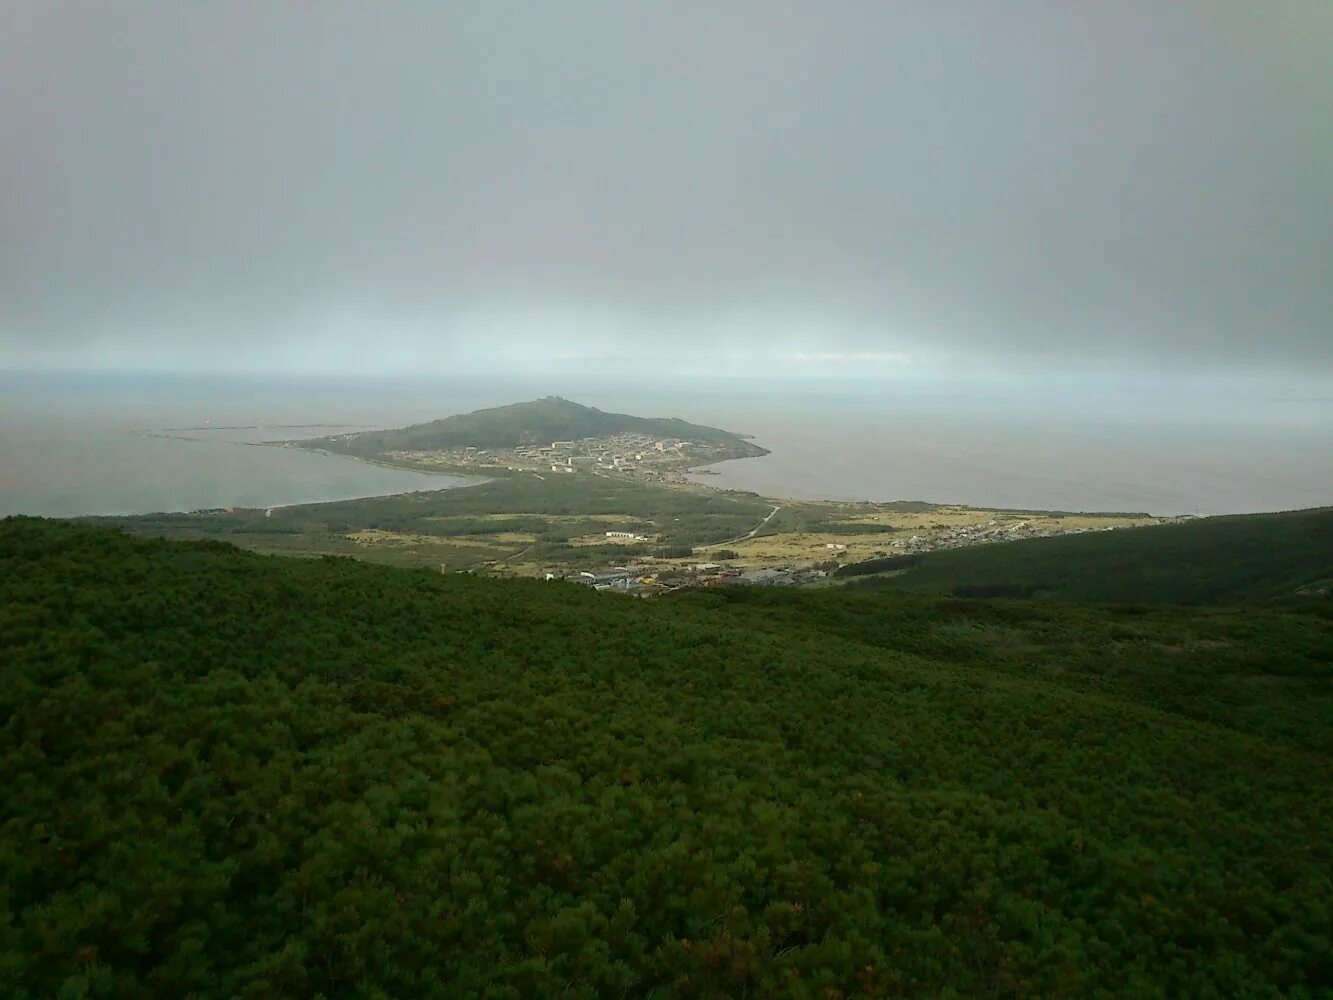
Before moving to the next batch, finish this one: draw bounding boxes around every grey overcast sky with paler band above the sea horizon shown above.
[0,0,1333,373]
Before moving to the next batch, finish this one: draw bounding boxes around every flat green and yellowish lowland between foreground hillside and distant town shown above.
[88,473,1178,576]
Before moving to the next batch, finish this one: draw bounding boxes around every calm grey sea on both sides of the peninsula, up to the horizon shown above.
[0,373,1333,516]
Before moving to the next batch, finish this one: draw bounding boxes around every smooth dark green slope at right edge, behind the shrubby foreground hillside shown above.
[840,507,1333,604]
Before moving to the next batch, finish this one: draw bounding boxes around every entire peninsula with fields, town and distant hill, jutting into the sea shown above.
[91,397,1178,589]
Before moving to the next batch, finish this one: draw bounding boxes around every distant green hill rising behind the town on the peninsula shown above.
[304,396,768,455]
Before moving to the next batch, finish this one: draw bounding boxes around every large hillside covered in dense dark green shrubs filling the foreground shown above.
[0,519,1333,997]
